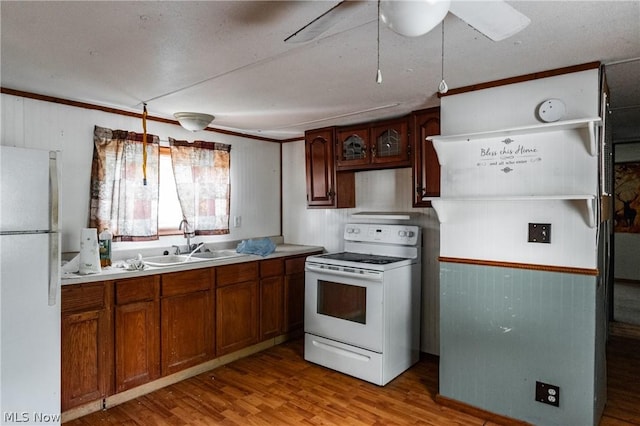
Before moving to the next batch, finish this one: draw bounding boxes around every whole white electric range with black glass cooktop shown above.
[305,223,422,386]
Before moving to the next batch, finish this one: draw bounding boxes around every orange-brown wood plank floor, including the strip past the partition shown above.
[65,336,640,426]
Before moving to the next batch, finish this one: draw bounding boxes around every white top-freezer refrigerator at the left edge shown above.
[0,146,60,425]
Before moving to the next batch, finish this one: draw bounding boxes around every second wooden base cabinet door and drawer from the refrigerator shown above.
[114,275,160,392]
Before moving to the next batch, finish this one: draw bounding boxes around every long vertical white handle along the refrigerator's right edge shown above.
[49,151,60,306]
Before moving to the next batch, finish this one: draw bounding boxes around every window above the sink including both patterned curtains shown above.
[89,126,231,241]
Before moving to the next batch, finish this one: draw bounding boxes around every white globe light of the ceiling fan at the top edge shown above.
[380,0,451,37]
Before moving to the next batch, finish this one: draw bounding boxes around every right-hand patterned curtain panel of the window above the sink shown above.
[169,138,231,235]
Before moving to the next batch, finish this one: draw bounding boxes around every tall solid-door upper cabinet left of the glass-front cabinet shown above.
[305,127,356,208]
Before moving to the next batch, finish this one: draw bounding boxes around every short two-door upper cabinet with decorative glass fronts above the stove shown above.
[336,117,411,171]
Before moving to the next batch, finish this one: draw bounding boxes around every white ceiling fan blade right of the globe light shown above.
[449,1,531,41]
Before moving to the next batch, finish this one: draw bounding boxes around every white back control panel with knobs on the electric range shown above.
[344,223,420,246]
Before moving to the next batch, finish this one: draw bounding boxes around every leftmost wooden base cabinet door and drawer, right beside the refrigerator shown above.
[61,282,113,411]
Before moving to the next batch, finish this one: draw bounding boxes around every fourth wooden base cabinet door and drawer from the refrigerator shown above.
[215,262,259,356]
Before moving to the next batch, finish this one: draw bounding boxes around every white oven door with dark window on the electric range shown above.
[304,262,384,353]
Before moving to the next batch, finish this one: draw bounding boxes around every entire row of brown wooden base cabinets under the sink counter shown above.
[61,252,319,412]
